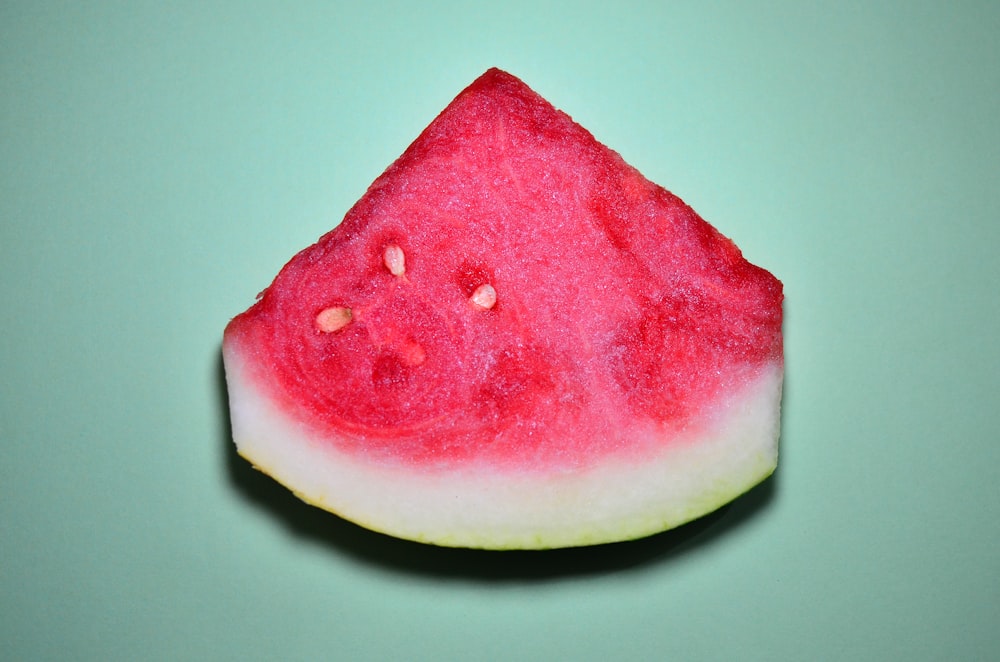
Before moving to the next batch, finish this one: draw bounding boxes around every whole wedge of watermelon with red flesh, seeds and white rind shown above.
[223,69,783,549]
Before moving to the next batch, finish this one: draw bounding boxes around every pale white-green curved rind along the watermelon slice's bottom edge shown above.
[223,343,782,549]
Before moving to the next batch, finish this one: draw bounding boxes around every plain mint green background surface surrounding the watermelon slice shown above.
[0,1,1000,660]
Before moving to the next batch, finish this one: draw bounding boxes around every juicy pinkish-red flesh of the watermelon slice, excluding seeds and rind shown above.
[225,69,782,472]
